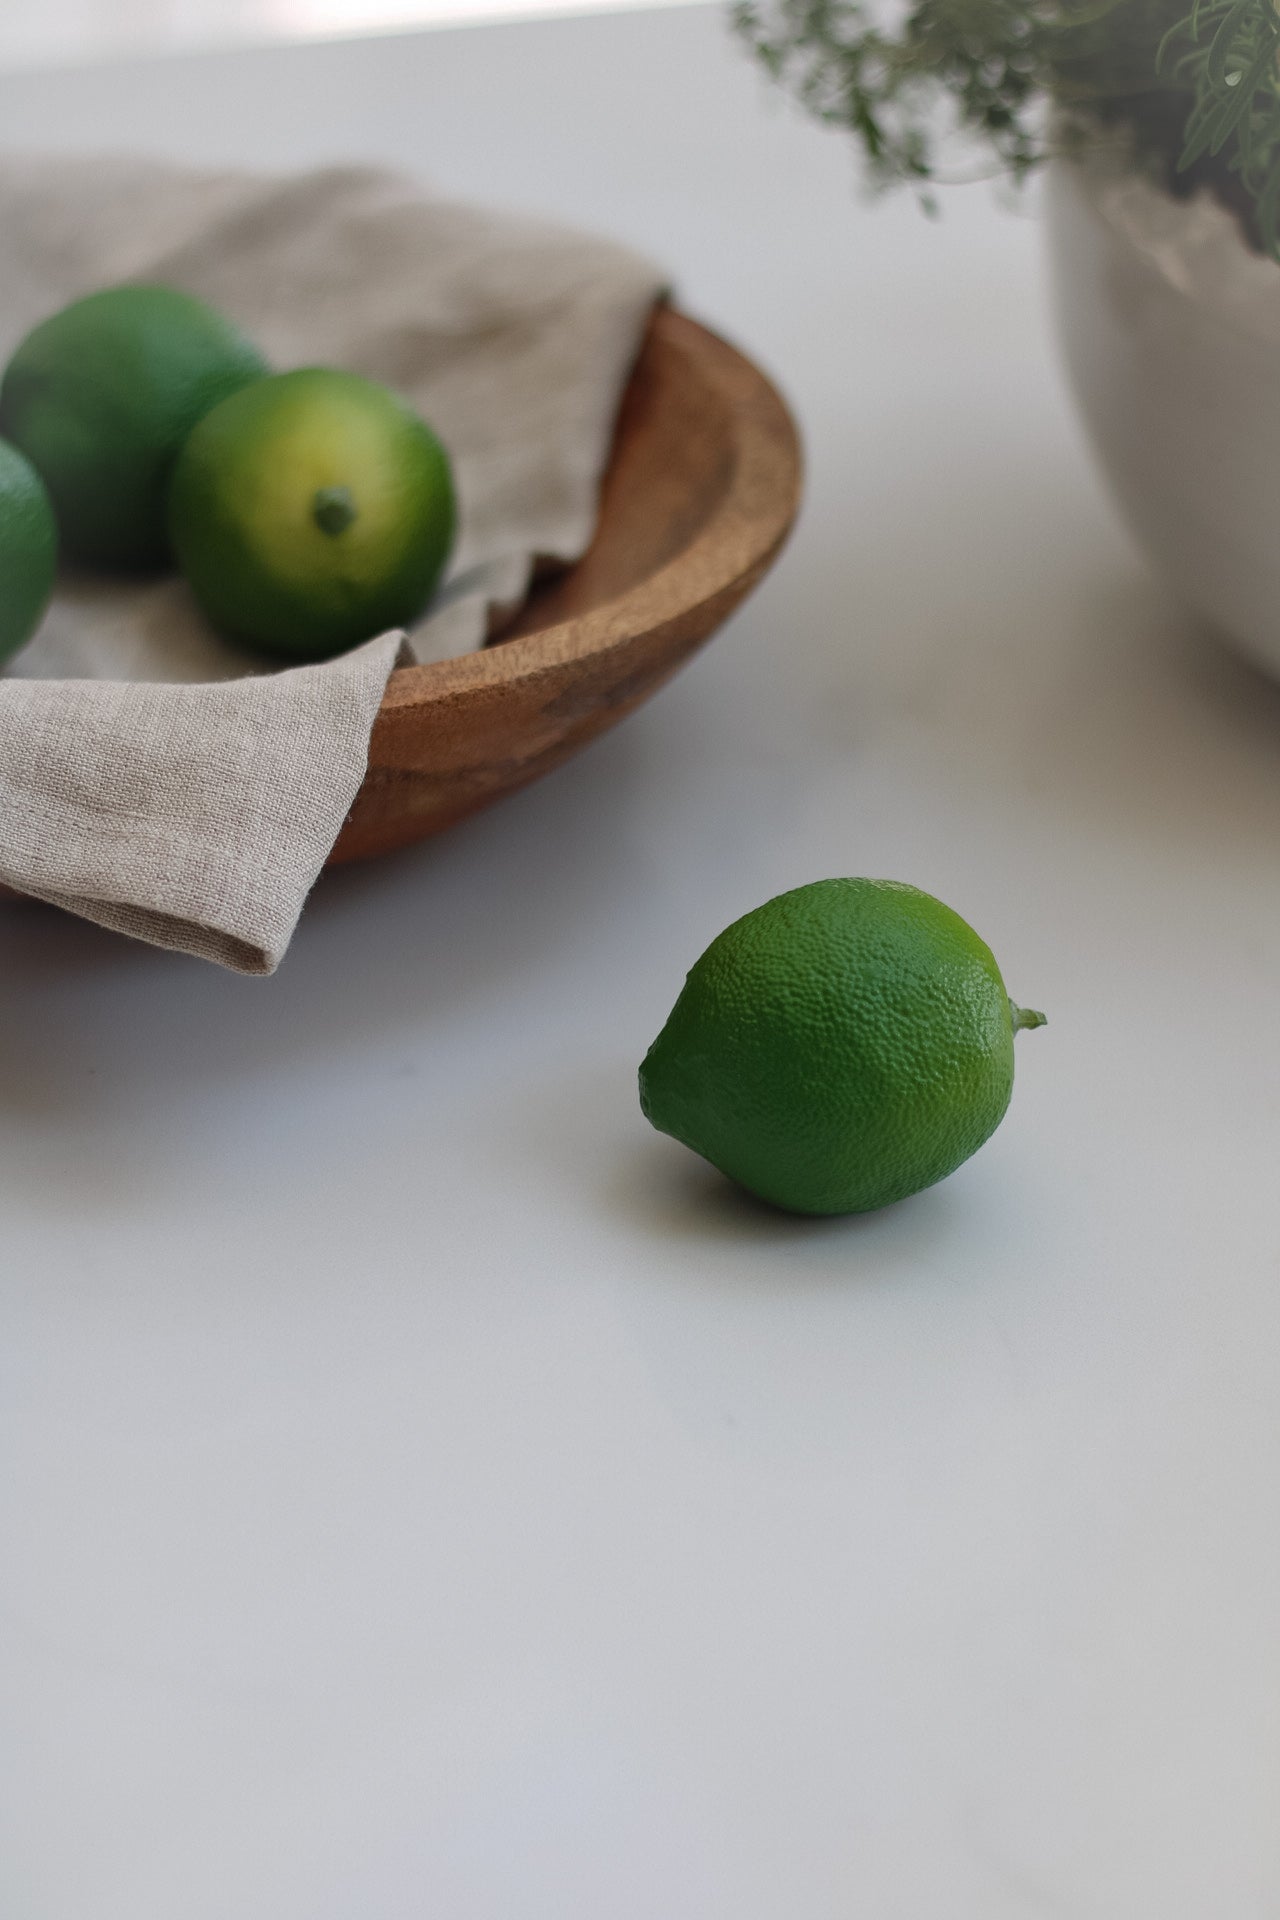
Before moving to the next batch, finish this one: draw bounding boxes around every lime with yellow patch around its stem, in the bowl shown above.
[169,367,455,660]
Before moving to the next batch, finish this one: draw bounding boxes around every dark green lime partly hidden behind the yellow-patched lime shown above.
[0,286,267,570]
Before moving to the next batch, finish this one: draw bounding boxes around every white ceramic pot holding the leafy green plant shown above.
[1048,156,1280,674]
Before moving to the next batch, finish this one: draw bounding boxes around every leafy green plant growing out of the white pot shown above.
[733,0,1280,255]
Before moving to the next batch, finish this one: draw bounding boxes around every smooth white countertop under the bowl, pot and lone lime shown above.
[0,10,1280,1920]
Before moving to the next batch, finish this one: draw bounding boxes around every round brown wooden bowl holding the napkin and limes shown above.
[330,307,800,864]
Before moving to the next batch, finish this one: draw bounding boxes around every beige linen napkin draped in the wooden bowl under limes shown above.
[0,156,662,973]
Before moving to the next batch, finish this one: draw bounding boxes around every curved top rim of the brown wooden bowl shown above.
[382,305,800,714]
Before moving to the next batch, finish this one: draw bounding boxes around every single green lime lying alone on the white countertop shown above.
[639,879,1044,1213]
